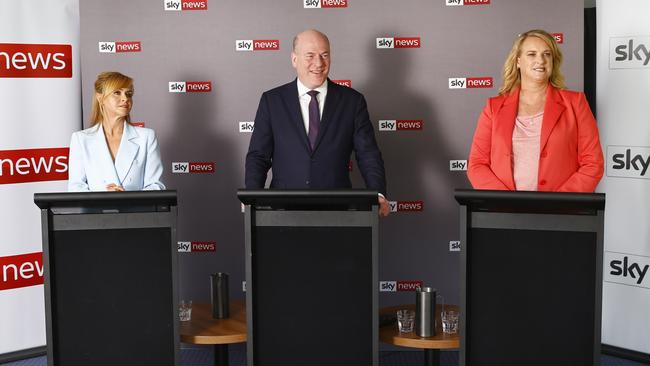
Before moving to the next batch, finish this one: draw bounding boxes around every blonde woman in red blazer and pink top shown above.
[467,30,603,192]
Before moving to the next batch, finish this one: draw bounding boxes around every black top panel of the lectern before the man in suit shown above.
[237,189,379,210]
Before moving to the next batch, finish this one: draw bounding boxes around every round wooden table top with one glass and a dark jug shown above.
[180,300,246,344]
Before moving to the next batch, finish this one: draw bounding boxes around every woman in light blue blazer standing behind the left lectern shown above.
[68,72,165,192]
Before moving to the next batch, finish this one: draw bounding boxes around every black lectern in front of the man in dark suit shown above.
[238,190,379,366]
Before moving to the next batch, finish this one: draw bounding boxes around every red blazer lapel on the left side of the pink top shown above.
[493,89,519,189]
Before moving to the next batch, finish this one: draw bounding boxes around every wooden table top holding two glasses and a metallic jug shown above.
[379,304,460,349]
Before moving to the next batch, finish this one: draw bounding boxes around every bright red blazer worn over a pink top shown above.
[467,85,603,192]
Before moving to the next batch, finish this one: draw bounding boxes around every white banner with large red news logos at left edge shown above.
[0,0,81,356]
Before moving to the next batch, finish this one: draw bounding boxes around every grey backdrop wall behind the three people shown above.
[79,0,584,320]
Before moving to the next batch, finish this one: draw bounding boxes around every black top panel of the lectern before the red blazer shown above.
[454,189,605,214]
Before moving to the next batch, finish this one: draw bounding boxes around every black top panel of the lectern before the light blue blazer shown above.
[34,190,177,209]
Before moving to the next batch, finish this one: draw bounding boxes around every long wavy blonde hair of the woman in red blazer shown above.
[499,29,566,95]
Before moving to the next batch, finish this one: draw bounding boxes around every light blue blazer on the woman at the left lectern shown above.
[68,122,165,192]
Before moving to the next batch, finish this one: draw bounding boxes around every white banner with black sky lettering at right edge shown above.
[596,0,650,354]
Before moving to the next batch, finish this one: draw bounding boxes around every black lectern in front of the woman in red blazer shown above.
[456,190,605,366]
